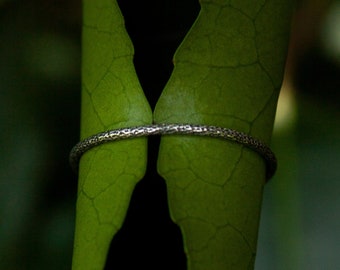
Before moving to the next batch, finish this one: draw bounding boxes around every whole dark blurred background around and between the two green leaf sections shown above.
[0,0,340,270]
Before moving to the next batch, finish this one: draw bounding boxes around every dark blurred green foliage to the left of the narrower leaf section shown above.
[0,1,80,269]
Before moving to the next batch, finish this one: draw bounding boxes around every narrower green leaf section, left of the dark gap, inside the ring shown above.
[72,0,152,270]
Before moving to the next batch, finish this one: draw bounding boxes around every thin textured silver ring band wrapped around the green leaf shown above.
[69,124,277,181]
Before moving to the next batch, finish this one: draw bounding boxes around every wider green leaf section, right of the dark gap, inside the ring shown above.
[154,0,292,270]
